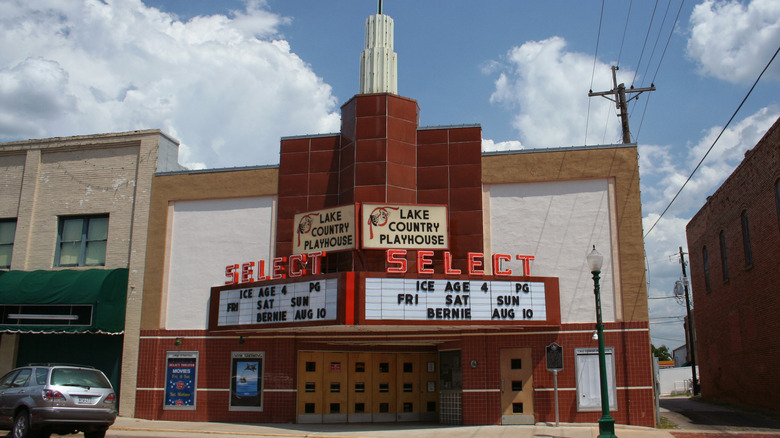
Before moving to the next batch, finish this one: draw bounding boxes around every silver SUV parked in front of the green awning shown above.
[0,364,116,438]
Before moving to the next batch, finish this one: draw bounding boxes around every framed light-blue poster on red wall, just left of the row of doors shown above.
[230,351,265,411]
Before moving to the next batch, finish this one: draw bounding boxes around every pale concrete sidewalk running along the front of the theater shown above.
[106,417,673,438]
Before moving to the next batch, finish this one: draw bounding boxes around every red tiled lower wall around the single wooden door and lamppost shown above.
[462,323,655,427]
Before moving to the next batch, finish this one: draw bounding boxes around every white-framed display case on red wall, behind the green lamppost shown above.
[574,347,617,411]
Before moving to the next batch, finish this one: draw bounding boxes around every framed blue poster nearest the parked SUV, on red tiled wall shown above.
[163,351,198,410]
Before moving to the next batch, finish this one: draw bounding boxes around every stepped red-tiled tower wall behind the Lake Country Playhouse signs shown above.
[276,94,483,272]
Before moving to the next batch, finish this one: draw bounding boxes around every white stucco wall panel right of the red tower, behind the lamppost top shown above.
[485,179,617,323]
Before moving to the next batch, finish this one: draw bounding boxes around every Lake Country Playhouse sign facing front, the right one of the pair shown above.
[360,204,449,249]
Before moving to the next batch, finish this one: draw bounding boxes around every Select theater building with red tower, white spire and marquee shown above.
[129,8,654,426]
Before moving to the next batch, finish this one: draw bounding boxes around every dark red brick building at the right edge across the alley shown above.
[686,115,780,413]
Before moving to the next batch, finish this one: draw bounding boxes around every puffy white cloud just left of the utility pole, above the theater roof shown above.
[494,36,633,148]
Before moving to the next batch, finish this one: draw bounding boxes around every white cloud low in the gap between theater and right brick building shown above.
[639,107,780,348]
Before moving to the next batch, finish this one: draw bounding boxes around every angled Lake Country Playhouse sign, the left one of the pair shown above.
[293,204,356,254]
